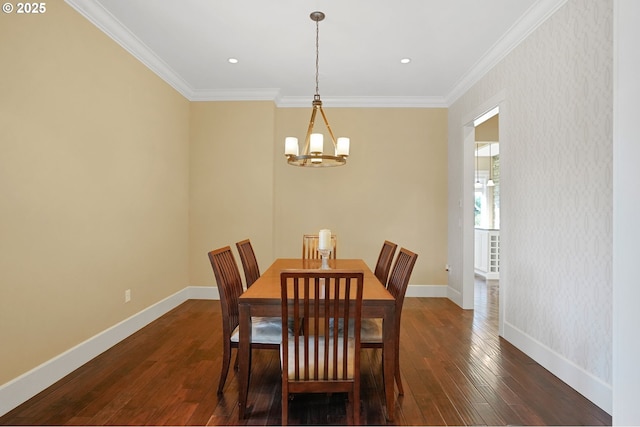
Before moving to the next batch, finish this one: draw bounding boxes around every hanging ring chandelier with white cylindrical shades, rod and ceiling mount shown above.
[284,12,349,168]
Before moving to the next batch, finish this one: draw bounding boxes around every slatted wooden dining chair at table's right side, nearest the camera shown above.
[361,248,418,395]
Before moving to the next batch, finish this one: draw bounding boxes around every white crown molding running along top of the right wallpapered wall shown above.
[445,0,567,106]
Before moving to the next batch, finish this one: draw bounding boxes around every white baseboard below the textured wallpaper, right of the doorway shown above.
[504,322,613,415]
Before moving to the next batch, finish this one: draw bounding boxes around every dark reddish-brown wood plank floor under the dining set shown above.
[0,280,611,425]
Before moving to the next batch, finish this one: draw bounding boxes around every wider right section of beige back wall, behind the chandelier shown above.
[274,108,447,285]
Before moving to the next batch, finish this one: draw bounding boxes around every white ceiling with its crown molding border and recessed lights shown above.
[66,0,566,107]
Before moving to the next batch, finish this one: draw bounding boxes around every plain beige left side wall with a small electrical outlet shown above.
[0,1,189,384]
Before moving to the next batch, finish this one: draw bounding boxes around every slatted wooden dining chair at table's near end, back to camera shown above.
[280,270,364,425]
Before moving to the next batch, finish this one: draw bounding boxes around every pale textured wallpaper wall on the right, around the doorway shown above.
[449,0,613,384]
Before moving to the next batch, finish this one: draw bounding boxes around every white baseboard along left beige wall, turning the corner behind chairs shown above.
[0,286,200,416]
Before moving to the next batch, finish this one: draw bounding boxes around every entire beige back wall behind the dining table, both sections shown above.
[190,102,447,286]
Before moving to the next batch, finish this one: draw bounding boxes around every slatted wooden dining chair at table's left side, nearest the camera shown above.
[209,246,282,393]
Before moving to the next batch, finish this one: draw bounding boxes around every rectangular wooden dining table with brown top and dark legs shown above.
[238,258,397,421]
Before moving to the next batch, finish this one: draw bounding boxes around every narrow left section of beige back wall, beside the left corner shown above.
[189,102,275,286]
